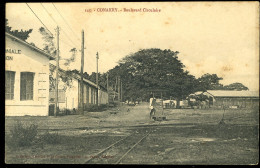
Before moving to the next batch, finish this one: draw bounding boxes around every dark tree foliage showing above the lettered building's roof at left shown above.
[5,19,33,41]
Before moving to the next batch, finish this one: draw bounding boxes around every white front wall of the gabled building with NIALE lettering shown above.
[5,36,49,116]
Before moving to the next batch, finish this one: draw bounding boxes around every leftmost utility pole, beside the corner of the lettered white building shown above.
[54,26,60,117]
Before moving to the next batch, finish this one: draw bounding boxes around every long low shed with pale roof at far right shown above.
[203,90,259,108]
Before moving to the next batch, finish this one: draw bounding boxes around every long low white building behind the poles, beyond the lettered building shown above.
[50,64,108,111]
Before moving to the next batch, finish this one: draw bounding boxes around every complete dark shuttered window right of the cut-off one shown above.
[20,72,34,100]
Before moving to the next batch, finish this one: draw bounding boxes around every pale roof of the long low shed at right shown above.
[206,90,259,97]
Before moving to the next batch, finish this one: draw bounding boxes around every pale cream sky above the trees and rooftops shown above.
[6,2,259,91]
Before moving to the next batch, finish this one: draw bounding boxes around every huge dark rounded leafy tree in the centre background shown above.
[105,48,196,100]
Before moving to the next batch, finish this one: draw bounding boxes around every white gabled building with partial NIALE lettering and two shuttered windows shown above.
[5,33,54,116]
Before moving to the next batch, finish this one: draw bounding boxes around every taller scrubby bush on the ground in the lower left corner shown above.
[10,121,38,147]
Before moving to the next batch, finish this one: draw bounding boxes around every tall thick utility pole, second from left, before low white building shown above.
[80,30,84,115]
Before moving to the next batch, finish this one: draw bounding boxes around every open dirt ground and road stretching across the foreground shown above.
[6,103,259,165]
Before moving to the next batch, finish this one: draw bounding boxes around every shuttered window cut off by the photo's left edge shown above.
[5,71,15,100]
